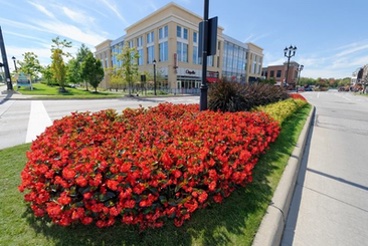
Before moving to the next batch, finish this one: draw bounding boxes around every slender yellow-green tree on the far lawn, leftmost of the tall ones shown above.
[51,37,72,92]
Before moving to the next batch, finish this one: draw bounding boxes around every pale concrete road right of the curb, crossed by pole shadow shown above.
[282,92,368,246]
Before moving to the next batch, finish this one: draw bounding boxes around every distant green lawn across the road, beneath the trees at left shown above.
[16,83,123,99]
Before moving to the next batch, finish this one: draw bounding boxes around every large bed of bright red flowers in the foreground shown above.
[19,104,280,229]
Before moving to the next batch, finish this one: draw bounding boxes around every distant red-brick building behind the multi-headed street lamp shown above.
[262,61,299,88]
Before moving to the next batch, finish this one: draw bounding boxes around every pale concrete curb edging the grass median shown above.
[252,106,316,246]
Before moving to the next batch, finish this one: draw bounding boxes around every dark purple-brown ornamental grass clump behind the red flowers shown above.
[208,80,289,112]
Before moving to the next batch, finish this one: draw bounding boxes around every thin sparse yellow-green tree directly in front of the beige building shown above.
[116,44,139,95]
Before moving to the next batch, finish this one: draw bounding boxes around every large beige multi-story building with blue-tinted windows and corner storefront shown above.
[96,3,263,89]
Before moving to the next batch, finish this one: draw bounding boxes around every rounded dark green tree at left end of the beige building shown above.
[81,52,104,92]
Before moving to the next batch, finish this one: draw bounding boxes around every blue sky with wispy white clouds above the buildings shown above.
[0,0,368,78]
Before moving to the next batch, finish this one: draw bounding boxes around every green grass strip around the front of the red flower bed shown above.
[0,105,311,246]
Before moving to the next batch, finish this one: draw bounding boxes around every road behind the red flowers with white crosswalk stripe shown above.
[0,91,199,149]
